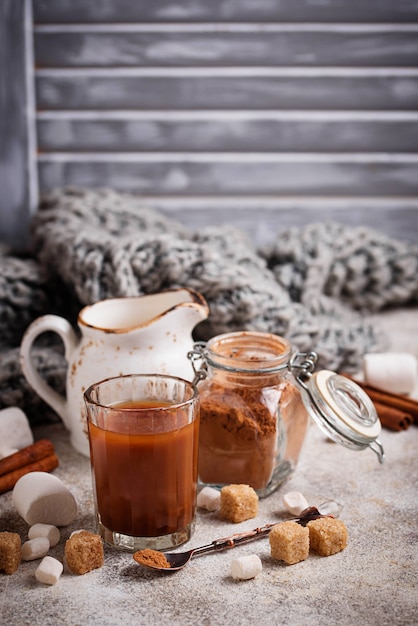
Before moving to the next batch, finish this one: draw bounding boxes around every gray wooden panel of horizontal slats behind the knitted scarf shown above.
[0,0,418,245]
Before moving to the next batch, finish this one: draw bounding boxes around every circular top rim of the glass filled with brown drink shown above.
[83,373,199,413]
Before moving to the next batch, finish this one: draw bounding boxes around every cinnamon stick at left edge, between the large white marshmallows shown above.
[0,439,59,494]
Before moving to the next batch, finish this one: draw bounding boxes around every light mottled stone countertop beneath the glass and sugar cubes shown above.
[0,310,418,626]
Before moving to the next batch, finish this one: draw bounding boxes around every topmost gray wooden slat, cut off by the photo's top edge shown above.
[33,0,418,23]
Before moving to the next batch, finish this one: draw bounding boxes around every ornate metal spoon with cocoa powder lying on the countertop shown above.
[133,507,327,572]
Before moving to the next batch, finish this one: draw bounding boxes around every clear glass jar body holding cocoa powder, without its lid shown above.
[199,333,308,491]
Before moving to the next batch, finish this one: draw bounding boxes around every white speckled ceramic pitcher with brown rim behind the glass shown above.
[20,289,209,456]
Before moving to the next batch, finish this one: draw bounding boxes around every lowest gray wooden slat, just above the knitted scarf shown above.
[155,201,418,249]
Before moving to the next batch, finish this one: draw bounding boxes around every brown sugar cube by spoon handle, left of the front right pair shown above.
[269,521,309,565]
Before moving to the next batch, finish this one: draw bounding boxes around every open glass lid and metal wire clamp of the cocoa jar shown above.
[188,342,385,463]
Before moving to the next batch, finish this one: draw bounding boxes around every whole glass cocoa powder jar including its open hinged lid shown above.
[189,331,384,497]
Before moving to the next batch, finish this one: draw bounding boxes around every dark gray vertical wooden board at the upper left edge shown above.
[0,0,38,247]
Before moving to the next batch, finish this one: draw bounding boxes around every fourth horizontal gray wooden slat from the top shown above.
[37,111,418,153]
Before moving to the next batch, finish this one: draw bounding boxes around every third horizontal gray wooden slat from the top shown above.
[36,71,418,111]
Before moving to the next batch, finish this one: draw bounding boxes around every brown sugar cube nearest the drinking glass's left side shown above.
[65,530,104,574]
